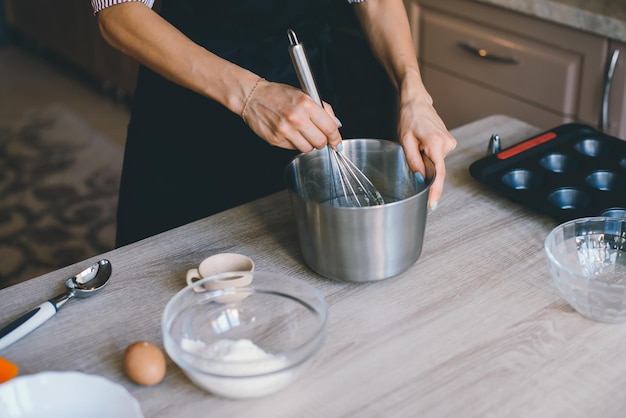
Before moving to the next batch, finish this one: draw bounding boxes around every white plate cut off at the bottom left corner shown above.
[0,372,143,418]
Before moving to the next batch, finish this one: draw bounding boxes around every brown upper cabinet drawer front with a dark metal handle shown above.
[420,10,582,115]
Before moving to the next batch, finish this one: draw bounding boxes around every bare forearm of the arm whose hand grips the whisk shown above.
[98,2,258,114]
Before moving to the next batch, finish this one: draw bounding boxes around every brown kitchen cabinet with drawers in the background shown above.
[405,0,626,138]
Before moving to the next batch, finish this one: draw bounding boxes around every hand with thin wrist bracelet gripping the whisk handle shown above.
[236,79,341,152]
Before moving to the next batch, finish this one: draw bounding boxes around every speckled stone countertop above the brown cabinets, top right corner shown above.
[473,0,626,42]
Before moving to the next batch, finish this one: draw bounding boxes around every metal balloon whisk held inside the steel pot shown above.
[287,29,385,207]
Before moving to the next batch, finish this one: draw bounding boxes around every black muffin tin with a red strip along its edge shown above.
[469,123,626,221]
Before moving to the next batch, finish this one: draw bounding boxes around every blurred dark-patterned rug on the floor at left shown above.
[0,105,123,288]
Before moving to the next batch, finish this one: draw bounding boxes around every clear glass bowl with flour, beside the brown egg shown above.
[162,271,328,399]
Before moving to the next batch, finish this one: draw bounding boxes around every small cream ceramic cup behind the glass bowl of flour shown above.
[185,253,254,292]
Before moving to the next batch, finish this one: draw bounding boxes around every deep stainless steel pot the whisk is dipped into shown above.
[285,139,435,282]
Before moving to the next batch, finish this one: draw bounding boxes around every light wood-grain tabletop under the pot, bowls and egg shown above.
[0,116,626,418]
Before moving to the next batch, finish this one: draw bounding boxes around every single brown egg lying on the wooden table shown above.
[124,341,165,386]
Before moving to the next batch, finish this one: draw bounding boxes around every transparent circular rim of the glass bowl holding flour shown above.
[161,270,328,378]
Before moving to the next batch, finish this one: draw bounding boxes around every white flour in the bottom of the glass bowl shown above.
[181,339,294,398]
